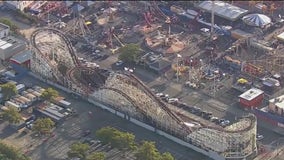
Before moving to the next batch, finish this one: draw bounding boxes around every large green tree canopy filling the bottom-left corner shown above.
[0,142,30,160]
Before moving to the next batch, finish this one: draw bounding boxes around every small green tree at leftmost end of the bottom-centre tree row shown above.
[67,142,90,159]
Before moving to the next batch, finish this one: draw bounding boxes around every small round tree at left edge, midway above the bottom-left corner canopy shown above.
[2,107,22,124]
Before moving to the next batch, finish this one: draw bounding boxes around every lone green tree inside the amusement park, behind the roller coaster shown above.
[118,43,142,62]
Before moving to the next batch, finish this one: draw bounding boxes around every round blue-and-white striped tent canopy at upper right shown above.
[242,14,271,27]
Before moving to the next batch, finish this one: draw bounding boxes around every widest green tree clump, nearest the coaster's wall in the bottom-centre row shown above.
[96,127,136,149]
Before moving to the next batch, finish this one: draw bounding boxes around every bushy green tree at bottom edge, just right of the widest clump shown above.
[135,141,161,160]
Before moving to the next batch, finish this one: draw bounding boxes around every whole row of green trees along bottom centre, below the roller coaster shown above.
[67,127,174,160]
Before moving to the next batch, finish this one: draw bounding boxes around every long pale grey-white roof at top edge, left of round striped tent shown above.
[197,1,248,21]
